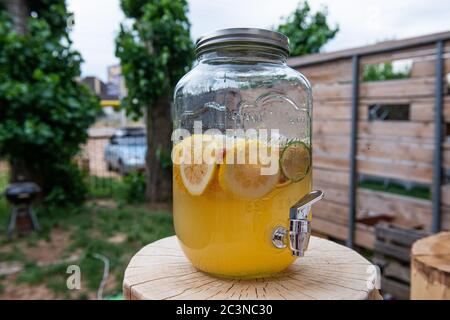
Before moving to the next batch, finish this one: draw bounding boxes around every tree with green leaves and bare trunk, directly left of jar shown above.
[116,0,194,202]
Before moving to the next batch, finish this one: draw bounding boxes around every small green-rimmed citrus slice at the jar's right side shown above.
[280,141,311,182]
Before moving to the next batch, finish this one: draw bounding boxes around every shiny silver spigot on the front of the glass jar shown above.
[272,190,323,257]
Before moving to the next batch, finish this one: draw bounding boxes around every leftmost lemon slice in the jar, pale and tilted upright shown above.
[175,136,217,196]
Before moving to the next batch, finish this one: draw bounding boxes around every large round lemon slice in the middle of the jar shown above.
[219,140,279,199]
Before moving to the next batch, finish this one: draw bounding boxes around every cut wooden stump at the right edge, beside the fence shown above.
[411,232,450,300]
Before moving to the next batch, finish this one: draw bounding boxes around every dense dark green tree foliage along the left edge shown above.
[0,0,99,203]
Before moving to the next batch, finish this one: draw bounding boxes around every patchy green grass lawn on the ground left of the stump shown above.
[0,172,174,299]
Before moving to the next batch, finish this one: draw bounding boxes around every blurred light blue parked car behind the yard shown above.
[105,128,147,175]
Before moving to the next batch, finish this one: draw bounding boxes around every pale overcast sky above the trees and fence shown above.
[68,0,450,79]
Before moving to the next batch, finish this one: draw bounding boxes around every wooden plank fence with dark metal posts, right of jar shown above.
[288,32,450,248]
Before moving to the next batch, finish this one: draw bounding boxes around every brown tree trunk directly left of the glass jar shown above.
[145,97,172,203]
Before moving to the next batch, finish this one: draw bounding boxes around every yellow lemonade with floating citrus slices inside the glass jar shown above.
[173,135,312,278]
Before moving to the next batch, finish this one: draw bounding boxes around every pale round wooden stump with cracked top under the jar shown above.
[123,237,381,300]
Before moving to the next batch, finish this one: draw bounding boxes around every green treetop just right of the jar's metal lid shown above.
[276,1,339,56]
